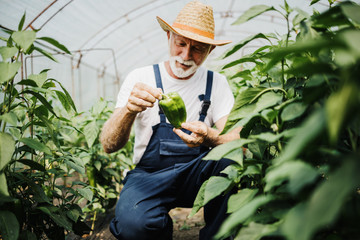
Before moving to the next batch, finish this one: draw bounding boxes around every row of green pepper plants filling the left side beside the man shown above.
[0,15,133,240]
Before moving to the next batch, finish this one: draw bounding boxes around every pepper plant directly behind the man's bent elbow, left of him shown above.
[61,99,134,220]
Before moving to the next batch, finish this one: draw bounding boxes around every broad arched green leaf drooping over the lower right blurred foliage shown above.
[264,161,318,195]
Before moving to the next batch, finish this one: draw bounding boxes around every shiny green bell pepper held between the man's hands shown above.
[159,92,186,128]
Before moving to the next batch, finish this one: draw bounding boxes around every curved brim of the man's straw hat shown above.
[156,17,231,46]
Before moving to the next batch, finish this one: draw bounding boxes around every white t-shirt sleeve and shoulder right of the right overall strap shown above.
[211,73,234,124]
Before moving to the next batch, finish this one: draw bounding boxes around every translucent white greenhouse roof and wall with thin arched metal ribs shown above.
[0,0,352,108]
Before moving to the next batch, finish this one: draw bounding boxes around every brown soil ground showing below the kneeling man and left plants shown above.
[67,208,205,240]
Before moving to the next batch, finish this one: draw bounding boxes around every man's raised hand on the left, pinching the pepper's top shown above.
[126,83,162,114]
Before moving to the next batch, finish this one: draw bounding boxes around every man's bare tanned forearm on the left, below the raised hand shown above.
[100,107,136,153]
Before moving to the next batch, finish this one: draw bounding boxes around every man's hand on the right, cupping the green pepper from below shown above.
[173,121,209,147]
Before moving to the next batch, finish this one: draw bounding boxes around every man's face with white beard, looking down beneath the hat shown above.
[168,32,214,78]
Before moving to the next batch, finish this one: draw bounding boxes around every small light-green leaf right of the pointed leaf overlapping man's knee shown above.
[227,188,259,213]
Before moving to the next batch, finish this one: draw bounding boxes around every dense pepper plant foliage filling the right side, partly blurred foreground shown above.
[192,1,360,240]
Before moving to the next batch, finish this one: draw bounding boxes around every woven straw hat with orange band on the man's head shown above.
[156,0,231,46]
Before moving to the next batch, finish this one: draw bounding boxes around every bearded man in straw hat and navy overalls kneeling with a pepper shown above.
[101,1,240,240]
